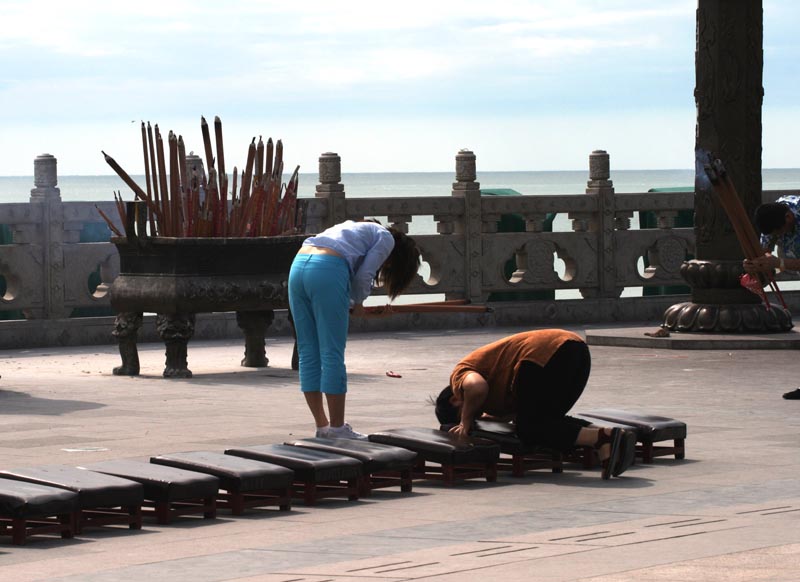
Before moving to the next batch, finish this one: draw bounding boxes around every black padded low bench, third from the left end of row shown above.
[84,460,219,524]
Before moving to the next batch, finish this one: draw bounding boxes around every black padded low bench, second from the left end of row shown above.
[0,465,144,534]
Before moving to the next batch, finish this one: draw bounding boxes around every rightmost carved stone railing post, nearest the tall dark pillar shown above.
[581,150,622,297]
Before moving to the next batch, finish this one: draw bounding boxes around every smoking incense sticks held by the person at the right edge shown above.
[697,151,787,309]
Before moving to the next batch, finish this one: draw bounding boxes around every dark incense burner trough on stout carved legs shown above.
[109,235,306,378]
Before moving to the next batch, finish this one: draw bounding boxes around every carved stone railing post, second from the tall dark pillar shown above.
[453,150,483,303]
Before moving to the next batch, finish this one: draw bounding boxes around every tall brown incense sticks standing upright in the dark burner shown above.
[100,117,300,237]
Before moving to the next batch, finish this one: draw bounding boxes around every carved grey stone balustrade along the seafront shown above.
[0,150,785,347]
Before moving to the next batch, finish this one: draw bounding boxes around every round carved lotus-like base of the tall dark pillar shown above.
[662,260,793,333]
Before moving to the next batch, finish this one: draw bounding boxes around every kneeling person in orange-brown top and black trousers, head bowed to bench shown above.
[436,329,636,479]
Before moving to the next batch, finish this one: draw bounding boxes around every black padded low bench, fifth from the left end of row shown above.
[225,445,362,506]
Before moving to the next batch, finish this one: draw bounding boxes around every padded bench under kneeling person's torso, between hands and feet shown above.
[470,420,564,477]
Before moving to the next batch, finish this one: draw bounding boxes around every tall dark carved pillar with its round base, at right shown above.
[664,0,792,333]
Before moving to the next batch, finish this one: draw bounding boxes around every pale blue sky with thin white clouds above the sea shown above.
[0,0,800,176]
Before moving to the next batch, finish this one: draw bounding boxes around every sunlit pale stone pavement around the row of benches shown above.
[0,328,800,582]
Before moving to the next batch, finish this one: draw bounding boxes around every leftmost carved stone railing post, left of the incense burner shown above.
[25,154,70,319]
